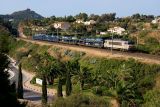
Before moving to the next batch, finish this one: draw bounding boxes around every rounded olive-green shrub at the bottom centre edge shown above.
[52,93,109,107]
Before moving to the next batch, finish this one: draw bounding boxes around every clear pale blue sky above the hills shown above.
[0,0,160,17]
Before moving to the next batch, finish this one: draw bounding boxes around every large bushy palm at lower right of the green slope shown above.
[102,65,138,107]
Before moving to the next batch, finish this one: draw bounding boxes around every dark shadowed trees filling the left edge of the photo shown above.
[0,20,25,107]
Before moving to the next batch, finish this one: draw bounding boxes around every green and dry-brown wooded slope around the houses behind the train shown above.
[21,13,160,55]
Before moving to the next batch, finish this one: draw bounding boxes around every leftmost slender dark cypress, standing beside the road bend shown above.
[17,63,23,99]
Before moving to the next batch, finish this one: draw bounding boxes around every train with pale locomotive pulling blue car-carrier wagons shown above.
[32,34,135,51]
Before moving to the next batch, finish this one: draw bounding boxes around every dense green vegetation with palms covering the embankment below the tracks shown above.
[7,37,160,107]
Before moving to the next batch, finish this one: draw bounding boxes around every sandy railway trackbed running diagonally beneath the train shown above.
[17,38,160,64]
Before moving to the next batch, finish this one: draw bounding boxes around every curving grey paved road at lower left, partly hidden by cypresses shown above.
[9,60,52,102]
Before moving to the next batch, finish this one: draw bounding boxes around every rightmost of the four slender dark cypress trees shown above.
[66,71,72,96]
